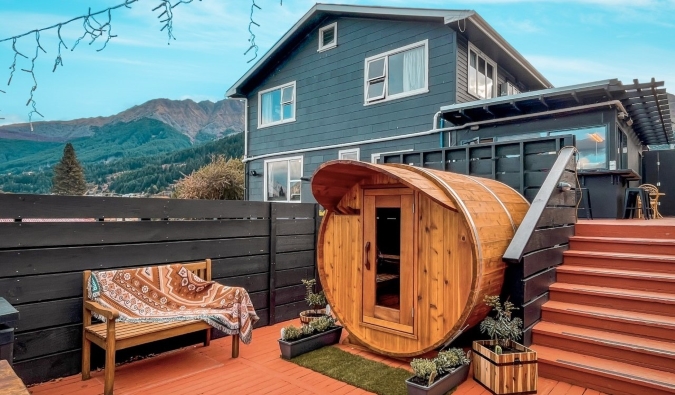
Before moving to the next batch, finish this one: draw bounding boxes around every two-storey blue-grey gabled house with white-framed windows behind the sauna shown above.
[227,4,551,202]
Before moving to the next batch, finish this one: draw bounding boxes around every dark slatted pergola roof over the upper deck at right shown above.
[441,78,675,145]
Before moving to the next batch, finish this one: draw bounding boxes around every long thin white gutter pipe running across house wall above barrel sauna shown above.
[243,100,628,163]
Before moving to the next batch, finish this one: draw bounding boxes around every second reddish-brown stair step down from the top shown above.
[570,236,675,255]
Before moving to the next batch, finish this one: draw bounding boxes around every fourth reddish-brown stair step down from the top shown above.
[556,265,675,294]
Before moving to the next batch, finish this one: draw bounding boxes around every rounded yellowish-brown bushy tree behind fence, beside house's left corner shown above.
[176,155,244,200]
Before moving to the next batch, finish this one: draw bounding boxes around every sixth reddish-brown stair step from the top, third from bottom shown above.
[542,300,675,341]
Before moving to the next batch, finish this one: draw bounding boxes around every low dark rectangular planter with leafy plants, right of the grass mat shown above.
[405,348,471,395]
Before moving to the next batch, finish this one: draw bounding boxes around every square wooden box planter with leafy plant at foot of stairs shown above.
[473,295,537,394]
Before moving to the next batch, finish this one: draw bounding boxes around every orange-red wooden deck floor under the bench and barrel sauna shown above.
[29,322,601,395]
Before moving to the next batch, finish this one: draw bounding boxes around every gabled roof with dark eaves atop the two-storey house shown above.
[226,3,553,98]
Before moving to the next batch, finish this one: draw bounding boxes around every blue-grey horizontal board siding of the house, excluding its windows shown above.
[236,6,552,202]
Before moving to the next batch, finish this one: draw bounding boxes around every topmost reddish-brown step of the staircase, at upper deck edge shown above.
[574,219,675,239]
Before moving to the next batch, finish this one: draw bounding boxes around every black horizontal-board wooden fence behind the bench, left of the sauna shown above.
[0,194,319,384]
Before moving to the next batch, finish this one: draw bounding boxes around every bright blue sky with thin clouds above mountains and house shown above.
[0,0,675,125]
